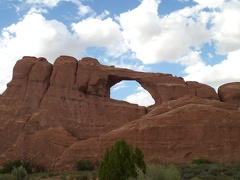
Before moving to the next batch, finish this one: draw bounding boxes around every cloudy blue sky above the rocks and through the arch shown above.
[0,0,240,105]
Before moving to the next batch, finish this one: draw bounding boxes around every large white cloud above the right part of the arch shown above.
[119,0,211,63]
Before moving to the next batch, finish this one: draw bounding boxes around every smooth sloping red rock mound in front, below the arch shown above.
[55,96,240,170]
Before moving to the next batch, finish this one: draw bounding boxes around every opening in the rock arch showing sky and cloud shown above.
[110,80,155,107]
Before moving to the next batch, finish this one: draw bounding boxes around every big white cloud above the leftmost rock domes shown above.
[2,13,81,62]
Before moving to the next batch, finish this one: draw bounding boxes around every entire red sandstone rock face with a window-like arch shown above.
[0,56,240,171]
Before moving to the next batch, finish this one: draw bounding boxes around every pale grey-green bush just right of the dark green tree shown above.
[137,165,181,180]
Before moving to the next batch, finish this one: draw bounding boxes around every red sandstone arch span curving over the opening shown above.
[76,57,219,105]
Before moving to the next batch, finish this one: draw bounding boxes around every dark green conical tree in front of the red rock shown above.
[99,140,146,180]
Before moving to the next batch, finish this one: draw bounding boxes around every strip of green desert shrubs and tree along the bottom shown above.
[0,140,240,180]
